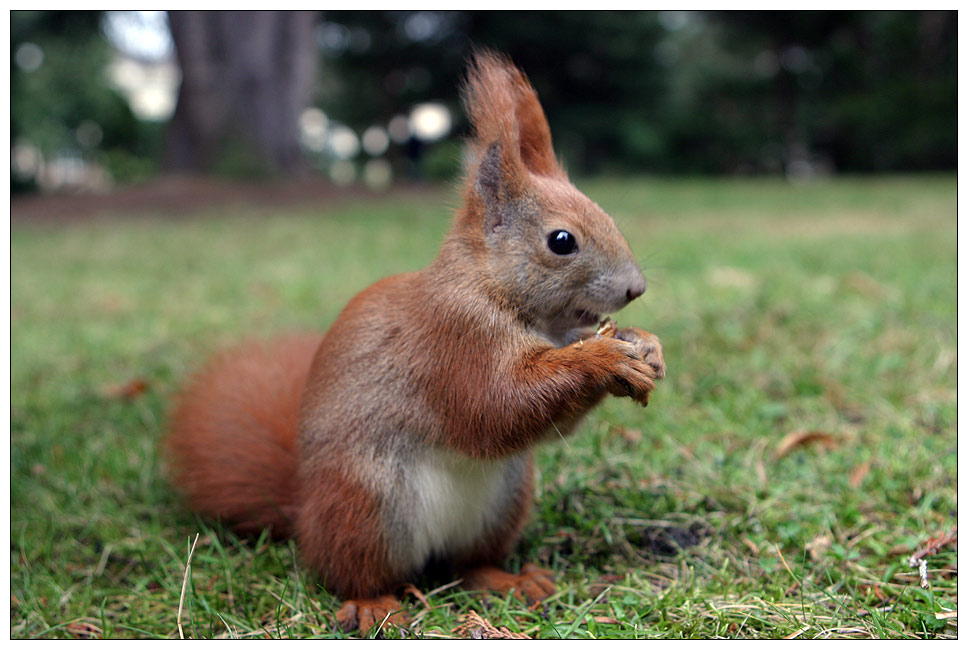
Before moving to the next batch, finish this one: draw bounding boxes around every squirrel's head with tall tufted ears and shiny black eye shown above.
[454,51,646,341]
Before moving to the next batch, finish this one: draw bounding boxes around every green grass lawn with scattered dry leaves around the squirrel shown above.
[10,177,957,638]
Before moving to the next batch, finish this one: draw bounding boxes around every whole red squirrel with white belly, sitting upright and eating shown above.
[164,51,665,631]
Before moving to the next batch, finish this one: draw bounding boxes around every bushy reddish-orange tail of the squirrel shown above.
[164,334,322,537]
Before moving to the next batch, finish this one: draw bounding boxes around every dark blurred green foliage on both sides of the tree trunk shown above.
[11,11,957,190]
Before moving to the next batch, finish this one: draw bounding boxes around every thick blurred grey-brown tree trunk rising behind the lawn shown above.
[163,11,317,172]
